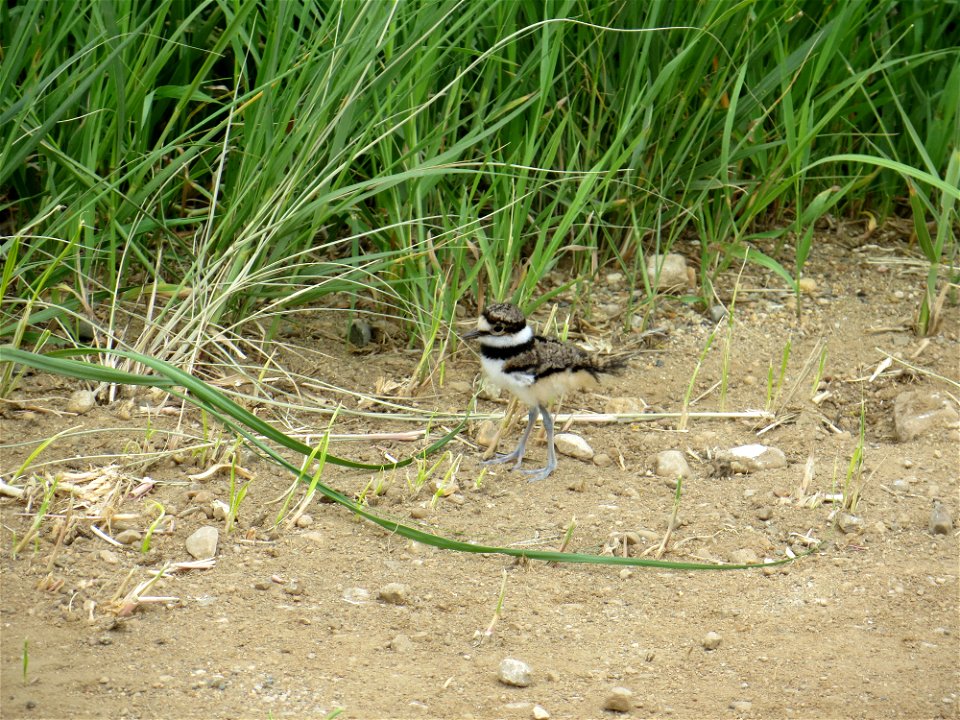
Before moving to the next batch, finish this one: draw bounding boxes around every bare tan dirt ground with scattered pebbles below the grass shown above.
[0,236,960,718]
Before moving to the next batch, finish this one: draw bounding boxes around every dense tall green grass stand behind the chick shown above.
[0,0,960,369]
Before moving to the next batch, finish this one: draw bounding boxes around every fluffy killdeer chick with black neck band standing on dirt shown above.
[464,303,623,482]
